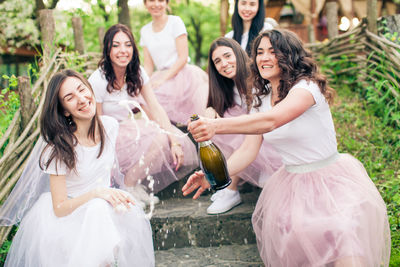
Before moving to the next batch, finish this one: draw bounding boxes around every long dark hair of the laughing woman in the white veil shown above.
[39,70,105,170]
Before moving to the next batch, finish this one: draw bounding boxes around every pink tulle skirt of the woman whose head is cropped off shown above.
[151,64,208,124]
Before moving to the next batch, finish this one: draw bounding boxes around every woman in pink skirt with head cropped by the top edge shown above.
[140,0,208,124]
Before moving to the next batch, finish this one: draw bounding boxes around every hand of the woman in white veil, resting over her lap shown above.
[95,187,135,209]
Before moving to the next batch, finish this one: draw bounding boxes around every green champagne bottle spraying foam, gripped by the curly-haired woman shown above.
[191,115,232,190]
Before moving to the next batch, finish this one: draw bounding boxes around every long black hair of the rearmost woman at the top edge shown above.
[232,0,265,56]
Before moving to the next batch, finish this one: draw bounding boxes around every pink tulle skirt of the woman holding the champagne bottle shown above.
[252,154,390,267]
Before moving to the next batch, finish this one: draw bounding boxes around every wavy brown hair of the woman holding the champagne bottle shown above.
[251,29,335,107]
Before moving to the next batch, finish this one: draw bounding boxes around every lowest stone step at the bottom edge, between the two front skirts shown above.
[155,244,264,267]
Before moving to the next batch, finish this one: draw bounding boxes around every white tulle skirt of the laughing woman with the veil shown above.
[5,192,155,267]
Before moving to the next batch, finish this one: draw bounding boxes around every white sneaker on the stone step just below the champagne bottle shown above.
[207,188,242,214]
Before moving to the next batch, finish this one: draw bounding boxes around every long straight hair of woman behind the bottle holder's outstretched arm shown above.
[207,37,251,117]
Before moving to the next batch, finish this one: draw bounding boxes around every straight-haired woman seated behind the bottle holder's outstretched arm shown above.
[206,37,282,214]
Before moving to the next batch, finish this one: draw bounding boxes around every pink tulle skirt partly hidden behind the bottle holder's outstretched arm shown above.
[212,105,282,187]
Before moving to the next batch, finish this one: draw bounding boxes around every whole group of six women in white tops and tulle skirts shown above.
[0,0,390,267]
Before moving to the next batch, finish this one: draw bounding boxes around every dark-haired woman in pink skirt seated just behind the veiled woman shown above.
[89,24,198,207]
